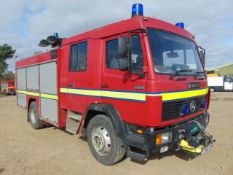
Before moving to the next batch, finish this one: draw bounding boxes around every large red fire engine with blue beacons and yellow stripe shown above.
[16,4,214,165]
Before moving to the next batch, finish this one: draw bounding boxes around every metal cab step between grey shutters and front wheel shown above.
[66,110,82,134]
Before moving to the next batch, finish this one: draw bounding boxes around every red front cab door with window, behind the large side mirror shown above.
[101,34,147,122]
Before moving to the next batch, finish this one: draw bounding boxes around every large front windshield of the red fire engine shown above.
[148,29,203,75]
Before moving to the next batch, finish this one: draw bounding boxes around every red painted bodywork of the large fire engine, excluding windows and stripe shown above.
[16,16,207,130]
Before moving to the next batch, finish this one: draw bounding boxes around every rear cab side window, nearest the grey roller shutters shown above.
[70,41,87,71]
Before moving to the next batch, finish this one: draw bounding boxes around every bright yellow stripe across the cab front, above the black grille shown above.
[147,88,208,101]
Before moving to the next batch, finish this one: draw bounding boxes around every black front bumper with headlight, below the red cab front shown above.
[125,113,209,159]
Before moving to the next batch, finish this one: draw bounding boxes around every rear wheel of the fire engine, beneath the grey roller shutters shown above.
[28,102,44,129]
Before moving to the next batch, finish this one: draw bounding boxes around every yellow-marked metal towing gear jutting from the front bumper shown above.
[178,121,215,154]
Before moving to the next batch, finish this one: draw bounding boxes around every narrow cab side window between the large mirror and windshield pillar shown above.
[131,34,143,72]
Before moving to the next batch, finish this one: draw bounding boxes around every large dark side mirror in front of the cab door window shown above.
[118,36,129,58]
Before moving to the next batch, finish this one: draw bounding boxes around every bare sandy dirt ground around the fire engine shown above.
[0,93,233,175]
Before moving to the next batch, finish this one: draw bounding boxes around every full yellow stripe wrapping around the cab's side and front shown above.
[60,88,208,101]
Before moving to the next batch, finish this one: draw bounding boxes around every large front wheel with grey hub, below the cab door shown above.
[87,115,125,165]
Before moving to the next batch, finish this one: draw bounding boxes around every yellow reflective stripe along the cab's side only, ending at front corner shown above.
[60,88,146,101]
